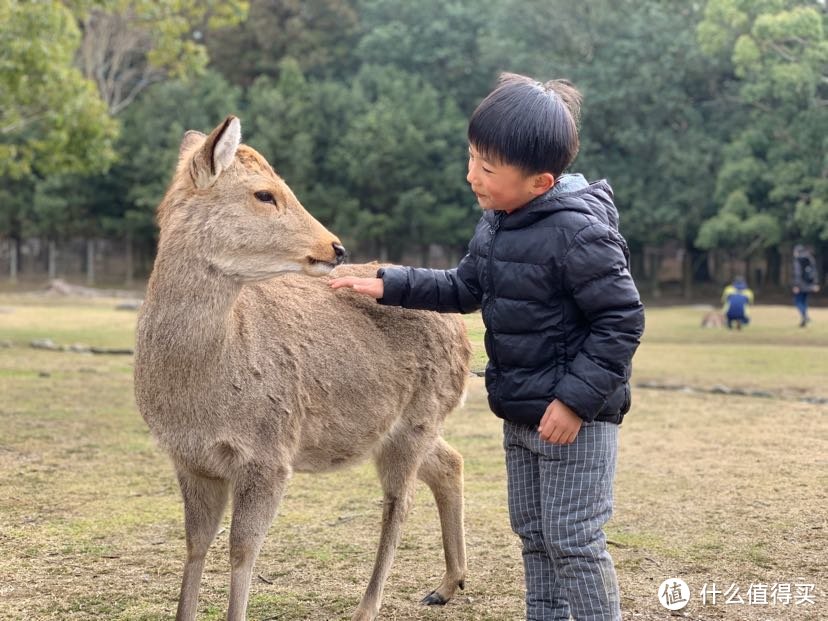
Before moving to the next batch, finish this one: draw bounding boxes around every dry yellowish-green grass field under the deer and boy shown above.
[0,294,828,621]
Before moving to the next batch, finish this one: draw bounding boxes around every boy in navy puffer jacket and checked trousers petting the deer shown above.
[331,74,644,621]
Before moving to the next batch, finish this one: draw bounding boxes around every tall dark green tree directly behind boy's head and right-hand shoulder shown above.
[483,0,731,295]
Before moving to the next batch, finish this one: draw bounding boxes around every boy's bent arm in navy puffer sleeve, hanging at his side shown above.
[555,225,644,421]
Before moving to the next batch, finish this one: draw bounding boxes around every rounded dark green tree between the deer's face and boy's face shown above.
[331,66,472,260]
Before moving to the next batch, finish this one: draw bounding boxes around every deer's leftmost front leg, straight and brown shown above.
[175,470,229,621]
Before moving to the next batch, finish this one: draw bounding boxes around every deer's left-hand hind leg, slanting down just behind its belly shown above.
[352,429,428,621]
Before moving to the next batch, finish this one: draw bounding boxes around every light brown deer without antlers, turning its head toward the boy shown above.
[134,116,471,621]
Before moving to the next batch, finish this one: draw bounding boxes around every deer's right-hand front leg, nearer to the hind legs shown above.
[227,466,290,621]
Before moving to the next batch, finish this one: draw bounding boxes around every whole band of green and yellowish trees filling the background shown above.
[0,0,828,284]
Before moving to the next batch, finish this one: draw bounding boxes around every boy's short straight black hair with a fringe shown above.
[468,73,581,179]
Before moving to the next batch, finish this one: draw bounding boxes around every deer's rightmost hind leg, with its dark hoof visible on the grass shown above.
[418,437,466,605]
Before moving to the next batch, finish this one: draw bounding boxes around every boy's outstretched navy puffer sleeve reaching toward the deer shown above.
[377,249,482,313]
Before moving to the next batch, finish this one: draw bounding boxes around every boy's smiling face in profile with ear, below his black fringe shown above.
[466,145,555,213]
